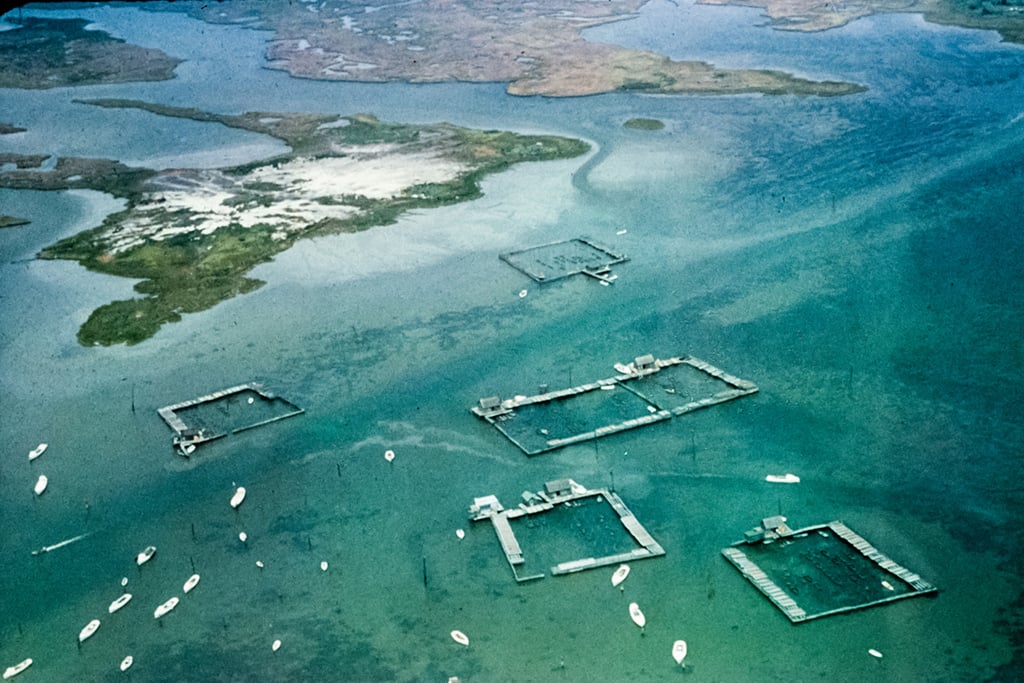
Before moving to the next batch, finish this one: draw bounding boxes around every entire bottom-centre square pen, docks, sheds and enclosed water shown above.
[469,478,665,583]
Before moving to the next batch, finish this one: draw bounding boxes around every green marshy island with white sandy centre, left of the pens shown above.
[0,99,589,346]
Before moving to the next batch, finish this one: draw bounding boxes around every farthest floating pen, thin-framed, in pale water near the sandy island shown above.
[498,238,629,285]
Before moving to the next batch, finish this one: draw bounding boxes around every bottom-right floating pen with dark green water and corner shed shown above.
[722,516,938,624]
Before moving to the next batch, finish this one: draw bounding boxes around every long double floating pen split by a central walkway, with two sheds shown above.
[470,354,758,456]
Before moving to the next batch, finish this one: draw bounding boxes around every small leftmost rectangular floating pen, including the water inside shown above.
[157,382,305,458]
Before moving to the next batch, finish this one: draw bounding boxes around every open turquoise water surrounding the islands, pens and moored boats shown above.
[0,5,1024,681]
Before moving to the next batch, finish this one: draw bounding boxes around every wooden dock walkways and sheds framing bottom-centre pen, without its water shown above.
[469,479,665,584]
